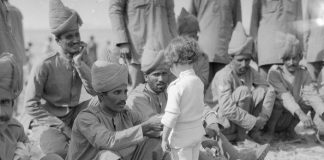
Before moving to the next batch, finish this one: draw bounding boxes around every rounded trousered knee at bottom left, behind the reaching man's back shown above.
[40,128,69,158]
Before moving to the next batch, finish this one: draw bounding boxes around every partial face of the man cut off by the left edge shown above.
[0,97,13,129]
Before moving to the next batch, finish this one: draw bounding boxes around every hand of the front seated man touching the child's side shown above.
[142,115,163,135]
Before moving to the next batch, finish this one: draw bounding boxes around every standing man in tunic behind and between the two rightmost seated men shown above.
[251,0,302,78]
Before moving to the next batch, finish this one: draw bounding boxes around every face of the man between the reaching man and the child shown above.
[145,69,169,93]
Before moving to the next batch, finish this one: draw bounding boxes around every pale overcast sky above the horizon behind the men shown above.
[9,0,189,29]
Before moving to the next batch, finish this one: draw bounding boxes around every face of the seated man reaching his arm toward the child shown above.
[101,85,127,113]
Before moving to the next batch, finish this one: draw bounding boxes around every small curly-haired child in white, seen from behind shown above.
[161,37,205,160]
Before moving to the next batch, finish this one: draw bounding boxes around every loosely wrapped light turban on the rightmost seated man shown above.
[275,32,302,59]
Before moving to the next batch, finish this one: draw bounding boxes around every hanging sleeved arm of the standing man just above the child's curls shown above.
[166,0,177,37]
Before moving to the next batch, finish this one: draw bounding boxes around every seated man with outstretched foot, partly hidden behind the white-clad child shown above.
[126,36,268,160]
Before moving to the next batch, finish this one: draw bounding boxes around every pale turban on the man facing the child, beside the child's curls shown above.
[141,39,167,74]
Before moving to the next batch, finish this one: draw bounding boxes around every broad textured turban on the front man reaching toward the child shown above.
[91,61,128,93]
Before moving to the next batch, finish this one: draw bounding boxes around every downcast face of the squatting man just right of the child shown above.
[231,54,251,75]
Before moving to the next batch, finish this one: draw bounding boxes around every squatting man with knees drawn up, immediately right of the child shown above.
[205,23,275,143]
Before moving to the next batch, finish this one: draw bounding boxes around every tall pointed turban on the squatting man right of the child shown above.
[228,22,253,56]
